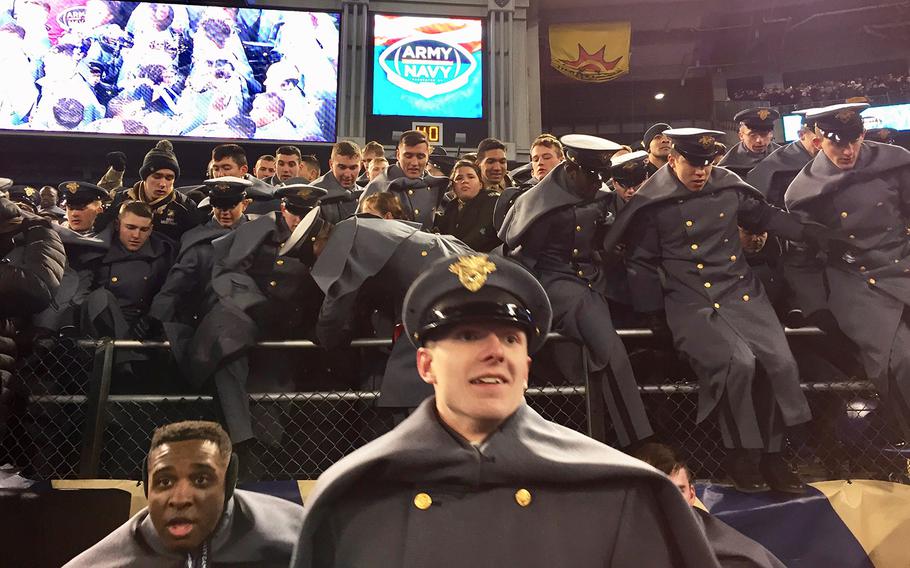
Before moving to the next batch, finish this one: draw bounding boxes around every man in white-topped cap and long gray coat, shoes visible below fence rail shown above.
[604,128,821,493]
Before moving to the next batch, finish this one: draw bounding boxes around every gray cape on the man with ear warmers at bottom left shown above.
[66,489,303,568]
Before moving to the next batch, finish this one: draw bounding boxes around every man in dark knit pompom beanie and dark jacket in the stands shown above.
[97,140,202,245]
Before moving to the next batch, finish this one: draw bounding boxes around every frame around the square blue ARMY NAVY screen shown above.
[364,12,490,122]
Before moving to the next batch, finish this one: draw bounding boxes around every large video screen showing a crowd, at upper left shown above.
[0,0,339,142]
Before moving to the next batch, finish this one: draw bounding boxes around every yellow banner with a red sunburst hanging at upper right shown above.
[550,22,632,83]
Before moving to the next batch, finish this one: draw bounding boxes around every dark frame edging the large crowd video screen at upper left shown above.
[0,0,344,146]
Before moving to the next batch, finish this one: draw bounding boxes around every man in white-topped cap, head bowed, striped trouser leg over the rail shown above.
[499,134,653,446]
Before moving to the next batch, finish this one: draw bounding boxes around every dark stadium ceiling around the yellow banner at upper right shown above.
[530,0,910,81]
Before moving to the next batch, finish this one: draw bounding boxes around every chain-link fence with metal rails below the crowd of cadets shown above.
[2,330,910,480]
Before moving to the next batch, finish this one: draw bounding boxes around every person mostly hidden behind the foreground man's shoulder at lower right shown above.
[634,442,785,568]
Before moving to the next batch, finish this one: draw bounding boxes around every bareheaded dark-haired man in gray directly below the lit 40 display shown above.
[361,130,449,230]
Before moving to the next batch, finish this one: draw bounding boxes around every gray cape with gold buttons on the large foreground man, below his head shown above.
[292,398,718,568]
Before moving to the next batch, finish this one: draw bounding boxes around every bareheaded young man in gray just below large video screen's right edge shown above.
[313,140,362,225]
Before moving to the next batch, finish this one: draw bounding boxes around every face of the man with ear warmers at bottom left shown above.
[148,440,227,552]
